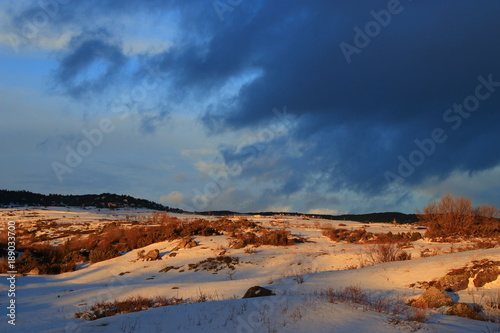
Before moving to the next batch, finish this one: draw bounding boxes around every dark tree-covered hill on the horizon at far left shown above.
[0,190,183,213]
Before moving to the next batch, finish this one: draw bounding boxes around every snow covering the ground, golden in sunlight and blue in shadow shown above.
[0,208,500,333]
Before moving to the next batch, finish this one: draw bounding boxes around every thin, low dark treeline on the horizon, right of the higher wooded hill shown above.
[198,210,418,223]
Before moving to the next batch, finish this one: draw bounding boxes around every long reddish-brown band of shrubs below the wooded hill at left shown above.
[0,213,264,274]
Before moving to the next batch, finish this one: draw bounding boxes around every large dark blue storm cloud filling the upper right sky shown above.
[193,1,500,193]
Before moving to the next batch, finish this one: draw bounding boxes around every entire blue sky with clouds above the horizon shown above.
[0,0,500,214]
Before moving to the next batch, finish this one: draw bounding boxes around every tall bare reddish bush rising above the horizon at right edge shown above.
[417,194,500,239]
